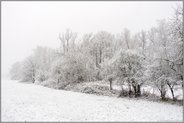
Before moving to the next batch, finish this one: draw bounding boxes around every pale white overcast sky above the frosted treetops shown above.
[1,1,182,73]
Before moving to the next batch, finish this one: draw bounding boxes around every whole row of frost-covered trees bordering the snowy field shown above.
[10,6,183,100]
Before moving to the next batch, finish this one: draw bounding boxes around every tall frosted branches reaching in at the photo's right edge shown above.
[168,5,184,80]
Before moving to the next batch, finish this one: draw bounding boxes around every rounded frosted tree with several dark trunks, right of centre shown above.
[114,50,144,97]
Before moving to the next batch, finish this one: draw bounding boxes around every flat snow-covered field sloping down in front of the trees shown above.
[1,79,183,121]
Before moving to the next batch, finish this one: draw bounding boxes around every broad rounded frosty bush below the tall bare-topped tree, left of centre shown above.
[52,53,91,83]
